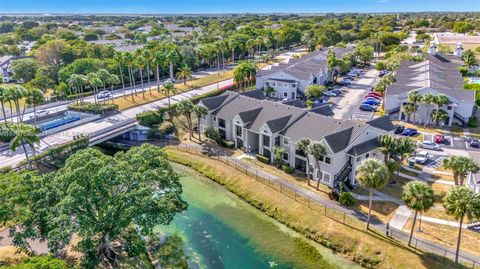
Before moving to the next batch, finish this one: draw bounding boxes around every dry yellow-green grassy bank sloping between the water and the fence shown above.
[165,148,461,268]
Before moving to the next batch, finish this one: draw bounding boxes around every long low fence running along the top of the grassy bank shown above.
[172,144,480,269]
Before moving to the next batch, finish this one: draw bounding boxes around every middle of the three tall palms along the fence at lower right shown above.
[402,181,435,246]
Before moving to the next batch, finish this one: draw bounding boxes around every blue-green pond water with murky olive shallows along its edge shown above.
[155,164,360,269]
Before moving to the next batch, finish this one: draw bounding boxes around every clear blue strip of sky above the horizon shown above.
[0,0,480,14]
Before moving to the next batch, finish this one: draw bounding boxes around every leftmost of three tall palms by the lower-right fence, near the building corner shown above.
[357,158,389,230]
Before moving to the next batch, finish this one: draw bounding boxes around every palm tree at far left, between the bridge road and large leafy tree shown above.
[10,123,40,170]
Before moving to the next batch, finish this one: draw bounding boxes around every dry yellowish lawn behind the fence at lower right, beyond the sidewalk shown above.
[403,219,480,255]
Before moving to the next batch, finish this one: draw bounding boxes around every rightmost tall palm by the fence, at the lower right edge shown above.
[443,186,480,262]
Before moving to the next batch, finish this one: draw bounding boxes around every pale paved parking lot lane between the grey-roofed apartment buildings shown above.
[327,69,378,121]
